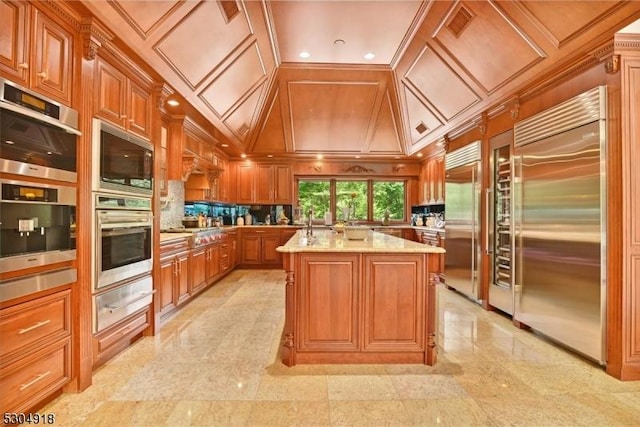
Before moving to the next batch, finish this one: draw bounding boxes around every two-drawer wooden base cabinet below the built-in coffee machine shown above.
[0,289,71,413]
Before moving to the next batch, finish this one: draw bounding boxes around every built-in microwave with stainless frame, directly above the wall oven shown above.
[92,119,153,197]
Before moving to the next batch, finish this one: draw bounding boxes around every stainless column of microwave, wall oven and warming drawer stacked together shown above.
[92,119,154,333]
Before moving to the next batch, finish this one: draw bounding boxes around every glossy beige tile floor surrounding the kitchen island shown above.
[42,270,640,426]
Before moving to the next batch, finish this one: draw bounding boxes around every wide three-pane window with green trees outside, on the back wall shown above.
[298,178,406,222]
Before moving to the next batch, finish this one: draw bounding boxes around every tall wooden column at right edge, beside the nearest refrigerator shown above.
[605,34,640,380]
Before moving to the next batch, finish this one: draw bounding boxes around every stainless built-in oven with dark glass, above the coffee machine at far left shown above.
[0,79,81,182]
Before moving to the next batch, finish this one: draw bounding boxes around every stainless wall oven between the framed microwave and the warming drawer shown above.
[93,194,153,290]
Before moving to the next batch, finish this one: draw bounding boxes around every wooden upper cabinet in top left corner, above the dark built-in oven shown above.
[0,0,73,105]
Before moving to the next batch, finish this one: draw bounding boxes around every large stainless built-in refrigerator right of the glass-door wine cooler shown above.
[514,87,606,363]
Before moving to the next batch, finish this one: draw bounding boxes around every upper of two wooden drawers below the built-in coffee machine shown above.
[0,290,71,362]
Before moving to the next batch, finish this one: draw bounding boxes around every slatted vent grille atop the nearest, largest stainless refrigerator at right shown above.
[513,86,607,147]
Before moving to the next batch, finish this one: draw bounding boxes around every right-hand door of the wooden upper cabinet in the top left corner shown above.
[31,9,73,104]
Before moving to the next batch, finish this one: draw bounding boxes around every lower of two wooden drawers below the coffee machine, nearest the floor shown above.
[0,338,71,413]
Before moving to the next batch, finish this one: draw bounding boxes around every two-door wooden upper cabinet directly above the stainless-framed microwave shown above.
[95,56,151,138]
